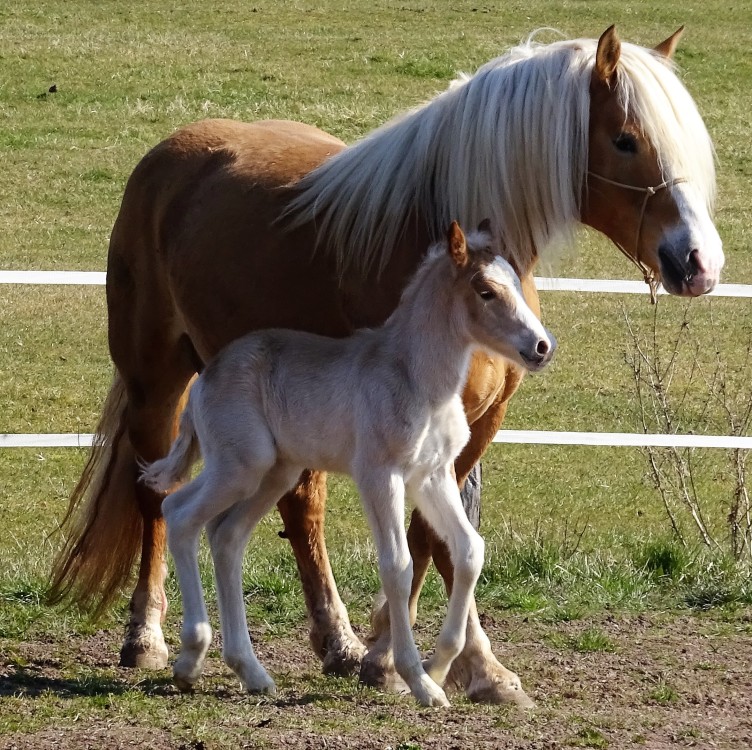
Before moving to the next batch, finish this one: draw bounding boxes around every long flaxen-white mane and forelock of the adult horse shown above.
[287,33,715,276]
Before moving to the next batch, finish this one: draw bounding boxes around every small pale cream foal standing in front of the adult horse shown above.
[143,223,555,706]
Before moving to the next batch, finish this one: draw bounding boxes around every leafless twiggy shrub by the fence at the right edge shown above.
[624,304,752,559]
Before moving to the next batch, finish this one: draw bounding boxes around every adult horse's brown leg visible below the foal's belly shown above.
[277,470,366,675]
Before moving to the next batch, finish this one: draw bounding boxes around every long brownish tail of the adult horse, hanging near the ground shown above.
[48,375,143,617]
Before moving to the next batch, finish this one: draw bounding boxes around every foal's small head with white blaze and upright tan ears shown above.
[447,222,556,372]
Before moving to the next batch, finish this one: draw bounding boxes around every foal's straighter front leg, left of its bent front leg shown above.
[354,469,449,706]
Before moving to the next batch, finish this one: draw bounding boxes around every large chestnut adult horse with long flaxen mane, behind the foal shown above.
[51,27,723,704]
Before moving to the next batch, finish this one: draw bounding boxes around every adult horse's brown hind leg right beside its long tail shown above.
[107,256,197,669]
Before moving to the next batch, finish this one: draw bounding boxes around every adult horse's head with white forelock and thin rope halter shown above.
[582,26,724,297]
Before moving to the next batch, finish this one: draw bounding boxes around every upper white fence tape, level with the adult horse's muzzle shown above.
[0,271,752,297]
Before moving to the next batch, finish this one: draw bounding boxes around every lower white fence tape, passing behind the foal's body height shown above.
[0,430,752,450]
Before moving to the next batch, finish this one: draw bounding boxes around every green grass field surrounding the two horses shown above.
[0,0,752,750]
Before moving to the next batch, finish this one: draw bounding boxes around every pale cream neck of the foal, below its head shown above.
[382,258,472,403]
